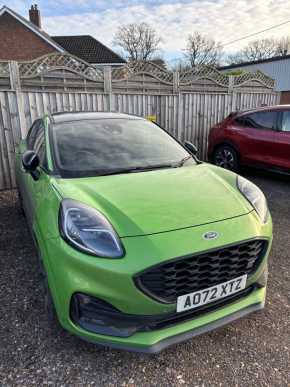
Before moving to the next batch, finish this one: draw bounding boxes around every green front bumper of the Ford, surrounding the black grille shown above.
[41,211,272,352]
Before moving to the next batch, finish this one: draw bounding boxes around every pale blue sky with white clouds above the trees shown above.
[0,0,290,64]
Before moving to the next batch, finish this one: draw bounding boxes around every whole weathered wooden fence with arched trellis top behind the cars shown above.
[0,54,279,189]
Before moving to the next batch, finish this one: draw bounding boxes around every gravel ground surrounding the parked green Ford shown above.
[0,172,290,386]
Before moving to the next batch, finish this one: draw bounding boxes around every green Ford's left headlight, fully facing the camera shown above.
[59,199,124,258]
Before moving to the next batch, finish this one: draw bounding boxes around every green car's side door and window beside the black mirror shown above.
[19,120,46,227]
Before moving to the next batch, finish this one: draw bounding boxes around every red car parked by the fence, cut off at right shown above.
[208,105,290,172]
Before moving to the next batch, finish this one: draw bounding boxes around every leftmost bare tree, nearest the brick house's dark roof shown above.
[113,23,161,61]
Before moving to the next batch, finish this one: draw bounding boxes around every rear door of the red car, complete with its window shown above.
[236,110,278,165]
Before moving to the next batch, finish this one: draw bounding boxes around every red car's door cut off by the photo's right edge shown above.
[274,110,290,169]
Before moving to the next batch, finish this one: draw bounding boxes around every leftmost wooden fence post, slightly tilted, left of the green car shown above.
[9,61,27,142]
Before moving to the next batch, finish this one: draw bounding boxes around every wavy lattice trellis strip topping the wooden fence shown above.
[0,53,274,95]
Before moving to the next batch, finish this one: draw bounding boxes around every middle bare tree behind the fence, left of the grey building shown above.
[185,32,222,67]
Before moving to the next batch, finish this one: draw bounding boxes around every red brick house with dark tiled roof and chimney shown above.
[0,5,126,66]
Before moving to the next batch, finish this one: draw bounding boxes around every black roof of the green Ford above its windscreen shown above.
[51,112,144,123]
